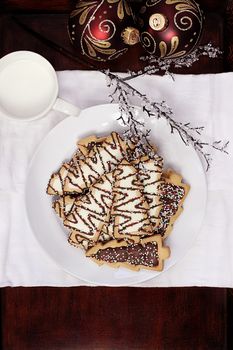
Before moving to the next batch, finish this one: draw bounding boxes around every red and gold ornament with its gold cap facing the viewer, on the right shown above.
[139,0,203,58]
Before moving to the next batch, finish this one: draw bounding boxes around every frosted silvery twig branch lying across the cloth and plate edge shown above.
[104,44,229,170]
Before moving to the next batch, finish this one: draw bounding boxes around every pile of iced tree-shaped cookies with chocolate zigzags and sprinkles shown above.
[47,132,189,271]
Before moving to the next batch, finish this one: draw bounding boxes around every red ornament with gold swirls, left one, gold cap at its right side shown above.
[68,0,139,61]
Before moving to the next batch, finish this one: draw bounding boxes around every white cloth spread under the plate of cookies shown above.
[0,71,233,288]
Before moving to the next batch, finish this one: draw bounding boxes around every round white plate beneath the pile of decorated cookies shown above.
[26,104,206,286]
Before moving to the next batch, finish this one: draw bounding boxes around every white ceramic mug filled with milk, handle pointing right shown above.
[0,51,80,121]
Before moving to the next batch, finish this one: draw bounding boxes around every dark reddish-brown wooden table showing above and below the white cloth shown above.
[0,0,233,350]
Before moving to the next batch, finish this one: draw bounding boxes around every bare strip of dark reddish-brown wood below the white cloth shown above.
[2,287,226,350]
